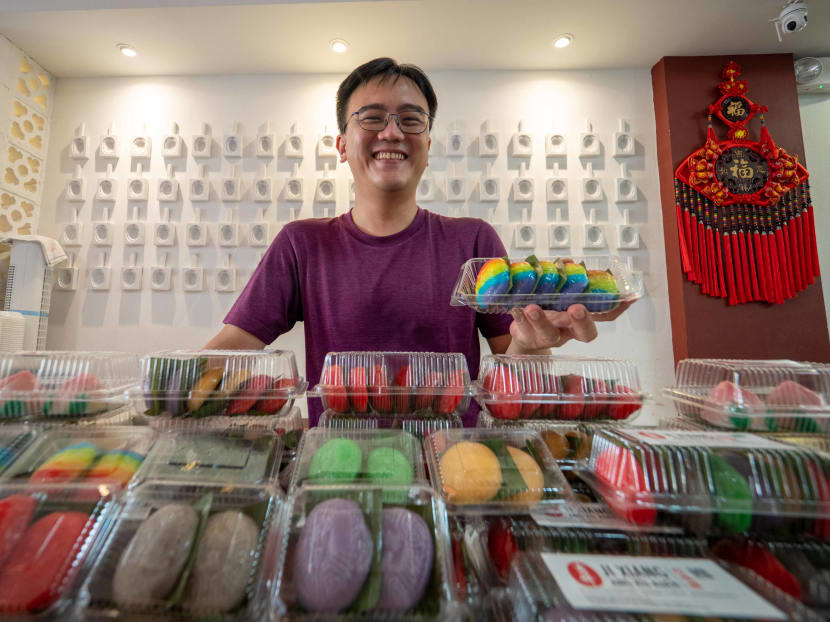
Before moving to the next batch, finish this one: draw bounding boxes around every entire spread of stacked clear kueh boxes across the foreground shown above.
[0,352,830,622]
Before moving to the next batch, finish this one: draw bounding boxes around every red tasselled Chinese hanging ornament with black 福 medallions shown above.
[674,61,819,305]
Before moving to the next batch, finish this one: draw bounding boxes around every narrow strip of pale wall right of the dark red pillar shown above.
[798,95,830,326]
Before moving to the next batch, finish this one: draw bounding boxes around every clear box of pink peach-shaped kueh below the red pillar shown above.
[664,359,830,433]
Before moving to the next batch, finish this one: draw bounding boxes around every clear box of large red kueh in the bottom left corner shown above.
[0,483,114,621]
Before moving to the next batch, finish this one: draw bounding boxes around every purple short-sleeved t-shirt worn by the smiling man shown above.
[225,208,512,425]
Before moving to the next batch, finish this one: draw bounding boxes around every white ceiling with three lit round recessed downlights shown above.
[0,0,830,78]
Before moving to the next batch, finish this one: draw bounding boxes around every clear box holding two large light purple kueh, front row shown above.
[272,485,466,621]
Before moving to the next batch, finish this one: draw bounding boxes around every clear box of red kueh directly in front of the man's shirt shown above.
[308,352,470,417]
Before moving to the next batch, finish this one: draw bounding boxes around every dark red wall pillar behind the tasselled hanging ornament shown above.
[651,54,830,362]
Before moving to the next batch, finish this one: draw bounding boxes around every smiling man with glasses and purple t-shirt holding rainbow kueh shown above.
[205,58,625,425]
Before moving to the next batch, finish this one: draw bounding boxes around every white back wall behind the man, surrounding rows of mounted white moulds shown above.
[40,69,673,424]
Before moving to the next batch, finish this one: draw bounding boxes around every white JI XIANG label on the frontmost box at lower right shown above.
[542,553,787,620]
